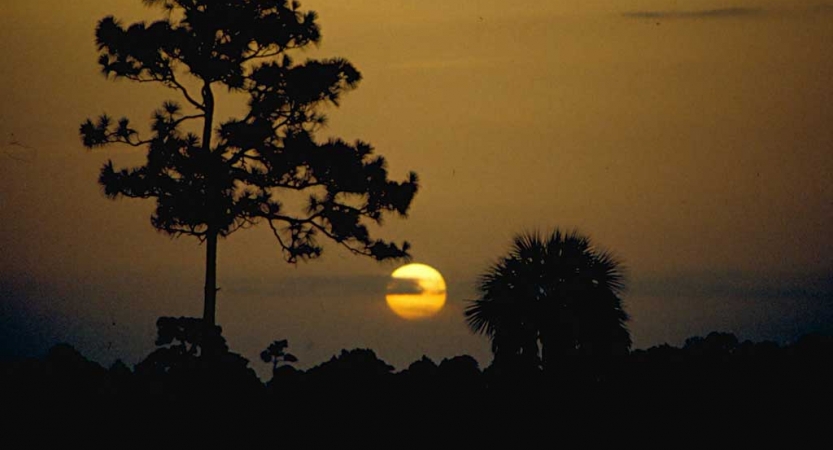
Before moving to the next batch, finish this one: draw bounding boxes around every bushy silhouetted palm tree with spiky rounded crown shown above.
[465,229,631,371]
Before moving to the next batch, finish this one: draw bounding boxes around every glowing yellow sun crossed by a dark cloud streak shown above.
[385,263,446,320]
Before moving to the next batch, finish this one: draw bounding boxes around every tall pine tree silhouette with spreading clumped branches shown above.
[80,0,417,325]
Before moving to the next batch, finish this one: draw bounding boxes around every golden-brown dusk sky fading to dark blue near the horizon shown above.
[0,0,833,372]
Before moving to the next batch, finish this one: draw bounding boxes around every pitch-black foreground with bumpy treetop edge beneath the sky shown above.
[0,333,833,442]
